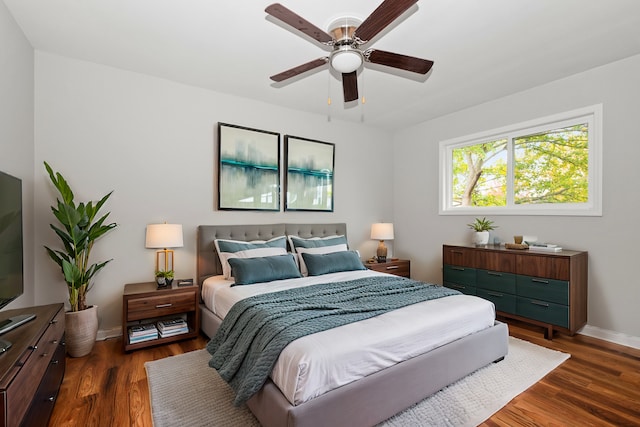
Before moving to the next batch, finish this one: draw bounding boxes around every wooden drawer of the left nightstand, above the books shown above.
[127,290,196,321]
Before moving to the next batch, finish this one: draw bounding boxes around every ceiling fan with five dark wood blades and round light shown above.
[265,0,433,102]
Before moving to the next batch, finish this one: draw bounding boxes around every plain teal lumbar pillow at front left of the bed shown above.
[229,254,302,286]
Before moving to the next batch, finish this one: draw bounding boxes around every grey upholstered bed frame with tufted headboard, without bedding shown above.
[197,223,508,426]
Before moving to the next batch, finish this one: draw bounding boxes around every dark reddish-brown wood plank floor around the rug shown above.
[49,322,640,427]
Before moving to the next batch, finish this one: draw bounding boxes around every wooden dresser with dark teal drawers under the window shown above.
[442,245,587,339]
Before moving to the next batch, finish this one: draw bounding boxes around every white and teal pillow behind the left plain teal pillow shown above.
[213,236,287,279]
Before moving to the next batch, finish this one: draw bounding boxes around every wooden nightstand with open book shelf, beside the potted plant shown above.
[122,280,200,351]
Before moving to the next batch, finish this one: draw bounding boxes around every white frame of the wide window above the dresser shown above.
[439,104,602,216]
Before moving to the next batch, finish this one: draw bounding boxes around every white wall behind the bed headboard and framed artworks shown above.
[35,52,392,335]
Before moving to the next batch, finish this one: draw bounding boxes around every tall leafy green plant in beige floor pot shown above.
[44,162,117,357]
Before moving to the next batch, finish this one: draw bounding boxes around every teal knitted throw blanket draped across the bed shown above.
[207,276,459,405]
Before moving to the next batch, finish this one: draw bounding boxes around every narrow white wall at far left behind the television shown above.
[0,2,34,309]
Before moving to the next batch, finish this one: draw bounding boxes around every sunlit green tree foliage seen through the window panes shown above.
[452,124,589,206]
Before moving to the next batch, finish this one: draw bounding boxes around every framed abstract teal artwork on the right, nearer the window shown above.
[284,135,335,212]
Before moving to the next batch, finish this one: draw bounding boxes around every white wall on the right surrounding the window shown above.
[393,56,640,346]
